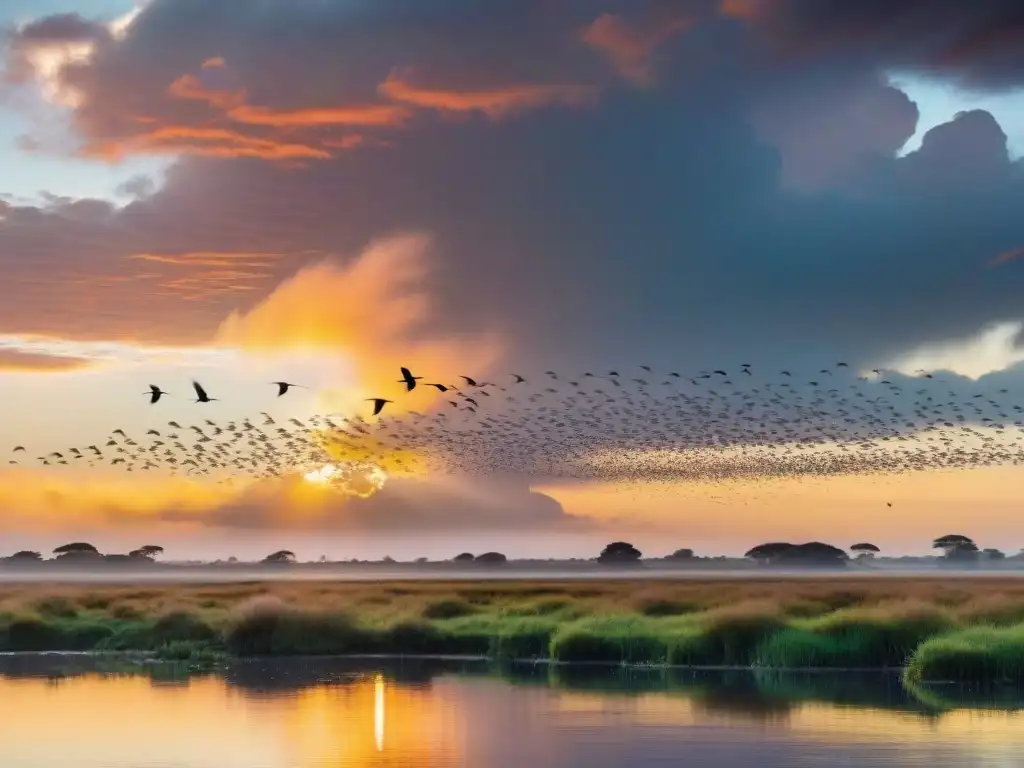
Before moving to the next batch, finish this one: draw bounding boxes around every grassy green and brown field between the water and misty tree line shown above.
[0,577,1024,682]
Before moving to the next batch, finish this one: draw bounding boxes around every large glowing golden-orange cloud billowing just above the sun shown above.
[215,234,501,413]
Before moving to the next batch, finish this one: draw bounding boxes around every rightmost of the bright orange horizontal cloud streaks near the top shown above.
[378,72,599,120]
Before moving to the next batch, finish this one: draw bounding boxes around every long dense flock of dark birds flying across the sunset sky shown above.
[11,362,1024,493]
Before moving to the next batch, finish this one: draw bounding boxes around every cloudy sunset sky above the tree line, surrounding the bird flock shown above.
[0,0,1024,559]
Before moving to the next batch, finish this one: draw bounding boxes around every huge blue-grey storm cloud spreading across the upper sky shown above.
[0,0,1024,368]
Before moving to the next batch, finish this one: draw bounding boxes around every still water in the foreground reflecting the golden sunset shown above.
[0,656,1024,768]
